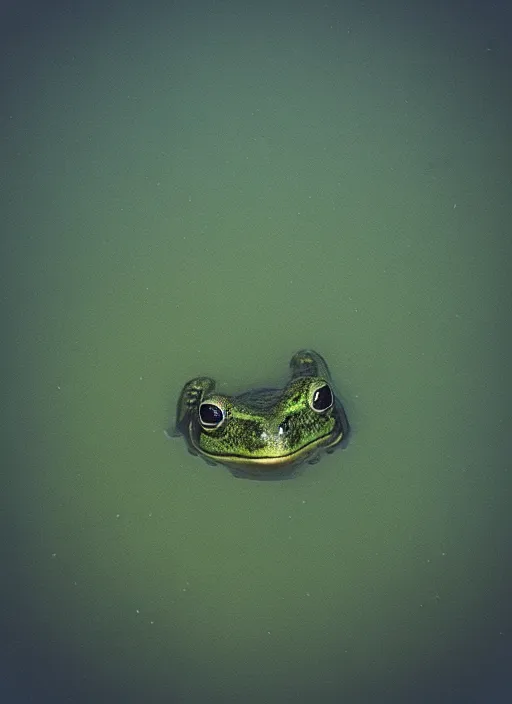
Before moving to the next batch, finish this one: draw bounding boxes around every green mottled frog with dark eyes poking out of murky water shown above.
[172,349,350,479]
